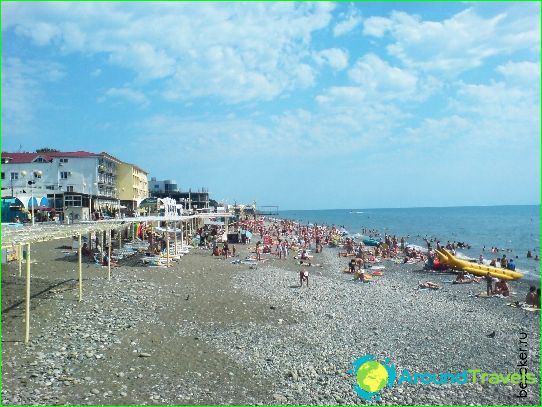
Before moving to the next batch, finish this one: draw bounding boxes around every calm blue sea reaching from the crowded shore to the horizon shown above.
[279,205,540,277]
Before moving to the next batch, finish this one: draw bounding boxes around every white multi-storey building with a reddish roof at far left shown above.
[2,151,121,217]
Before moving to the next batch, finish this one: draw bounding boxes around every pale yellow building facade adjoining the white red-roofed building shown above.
[117,163,149,212]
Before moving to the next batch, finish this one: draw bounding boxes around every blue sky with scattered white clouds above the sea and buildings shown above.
[2,2,540,209]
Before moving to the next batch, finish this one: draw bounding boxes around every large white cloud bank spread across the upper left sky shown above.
[2,3,334,103]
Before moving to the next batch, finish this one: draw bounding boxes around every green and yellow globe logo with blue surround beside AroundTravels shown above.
[349,355,395,400]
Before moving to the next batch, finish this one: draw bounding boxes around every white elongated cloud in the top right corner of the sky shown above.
[364,9,540,76]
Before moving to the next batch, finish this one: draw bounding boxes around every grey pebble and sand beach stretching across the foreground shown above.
[2,231,540,405]
